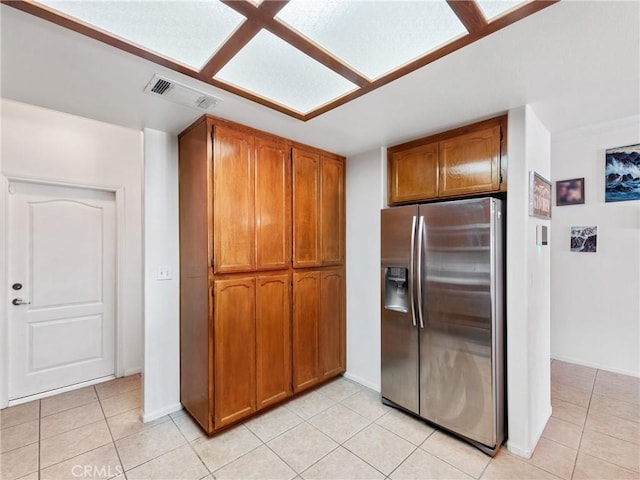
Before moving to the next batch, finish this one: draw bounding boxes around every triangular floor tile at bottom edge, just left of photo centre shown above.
[214,445,296,480]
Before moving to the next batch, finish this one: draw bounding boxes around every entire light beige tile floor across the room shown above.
[0,361,640,480]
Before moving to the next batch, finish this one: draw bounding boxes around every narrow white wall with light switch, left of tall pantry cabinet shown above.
[142,129,182,421]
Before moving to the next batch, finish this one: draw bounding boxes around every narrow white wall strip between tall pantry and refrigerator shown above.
[346,149,386,391]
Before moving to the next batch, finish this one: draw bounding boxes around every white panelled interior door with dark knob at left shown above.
[7,181,116,400]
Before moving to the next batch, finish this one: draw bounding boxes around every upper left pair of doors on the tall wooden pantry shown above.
[213,125,291,273]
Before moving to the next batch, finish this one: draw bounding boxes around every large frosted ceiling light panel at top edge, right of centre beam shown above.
[276,0,467,79]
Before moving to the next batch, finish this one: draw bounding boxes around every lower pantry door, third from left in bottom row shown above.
[293,272,320,392]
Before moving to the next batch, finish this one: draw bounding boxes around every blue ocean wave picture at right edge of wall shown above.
[605,144,640,202]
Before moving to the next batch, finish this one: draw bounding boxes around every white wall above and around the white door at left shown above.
[0,99,143,406]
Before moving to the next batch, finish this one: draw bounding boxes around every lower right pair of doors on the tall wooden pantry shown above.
[293,268,346,392]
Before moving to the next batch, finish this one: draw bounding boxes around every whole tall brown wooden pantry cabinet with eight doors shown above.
[179,116,345,433]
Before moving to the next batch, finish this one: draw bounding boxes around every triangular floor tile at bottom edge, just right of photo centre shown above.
[302,447,385,480]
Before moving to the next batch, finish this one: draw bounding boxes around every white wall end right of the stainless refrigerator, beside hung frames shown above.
[506,106,551,458]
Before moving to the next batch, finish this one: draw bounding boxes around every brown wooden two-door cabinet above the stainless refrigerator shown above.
[387,116,507,205]
